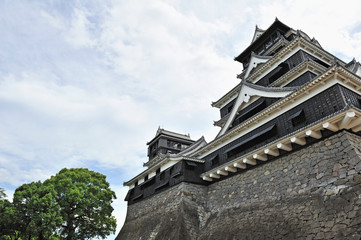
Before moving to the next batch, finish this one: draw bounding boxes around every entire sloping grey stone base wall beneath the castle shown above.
[117,131,361,240]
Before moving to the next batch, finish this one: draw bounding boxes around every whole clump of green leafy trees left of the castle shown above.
[0,168,116,240]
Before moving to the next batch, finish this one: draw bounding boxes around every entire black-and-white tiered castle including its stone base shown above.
[117,19,361,239]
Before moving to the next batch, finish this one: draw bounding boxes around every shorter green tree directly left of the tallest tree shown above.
[13,181,62,240]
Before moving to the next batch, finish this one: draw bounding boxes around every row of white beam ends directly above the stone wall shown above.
[200,108,361,182]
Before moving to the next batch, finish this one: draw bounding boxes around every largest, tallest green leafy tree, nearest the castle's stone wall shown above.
[44,168,116,240]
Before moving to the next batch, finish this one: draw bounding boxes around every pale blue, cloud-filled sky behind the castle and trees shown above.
[0,0,361,239]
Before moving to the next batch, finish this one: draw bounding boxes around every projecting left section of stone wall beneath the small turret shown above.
[116,183,209,240]
